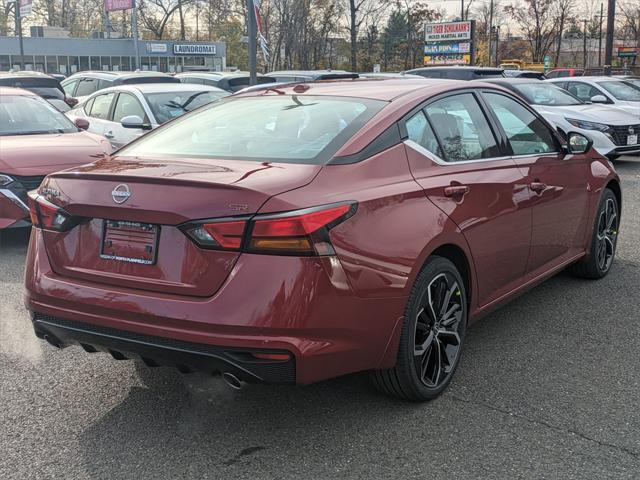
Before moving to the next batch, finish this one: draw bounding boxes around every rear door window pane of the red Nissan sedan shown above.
[425,93,499,162]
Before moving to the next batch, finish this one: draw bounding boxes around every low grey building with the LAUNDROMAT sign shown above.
[0,37,226,75]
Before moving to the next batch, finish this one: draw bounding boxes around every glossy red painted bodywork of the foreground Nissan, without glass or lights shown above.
[26,80,617,383]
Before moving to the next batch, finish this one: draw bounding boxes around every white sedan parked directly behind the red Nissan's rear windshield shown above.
[67,83,229,148]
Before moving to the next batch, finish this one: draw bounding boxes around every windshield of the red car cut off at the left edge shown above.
[0,95,78,136]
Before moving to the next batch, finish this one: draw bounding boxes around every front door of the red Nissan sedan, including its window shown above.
[482,91,588,275]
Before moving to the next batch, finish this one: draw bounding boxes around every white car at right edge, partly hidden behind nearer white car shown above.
[546,77,640,120]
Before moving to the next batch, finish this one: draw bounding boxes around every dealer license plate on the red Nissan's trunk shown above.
[100,220,160,265]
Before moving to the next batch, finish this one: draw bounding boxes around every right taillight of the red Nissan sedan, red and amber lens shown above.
[180,203,357,256]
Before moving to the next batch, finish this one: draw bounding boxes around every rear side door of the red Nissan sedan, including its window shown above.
[405,92,531,306]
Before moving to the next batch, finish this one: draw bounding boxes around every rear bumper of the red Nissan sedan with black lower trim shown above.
[25,229,406,384]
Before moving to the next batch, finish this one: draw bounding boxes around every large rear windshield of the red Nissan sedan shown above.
[120,95,386,164]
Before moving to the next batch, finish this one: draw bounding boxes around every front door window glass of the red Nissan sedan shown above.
[484,93,557,155]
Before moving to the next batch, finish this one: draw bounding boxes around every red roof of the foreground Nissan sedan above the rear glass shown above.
[236,77,469,102]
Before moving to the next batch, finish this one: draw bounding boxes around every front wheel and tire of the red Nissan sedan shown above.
[571,188,620,279]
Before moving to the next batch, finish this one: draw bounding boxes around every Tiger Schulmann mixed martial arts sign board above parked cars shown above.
[424,20,475,66]
